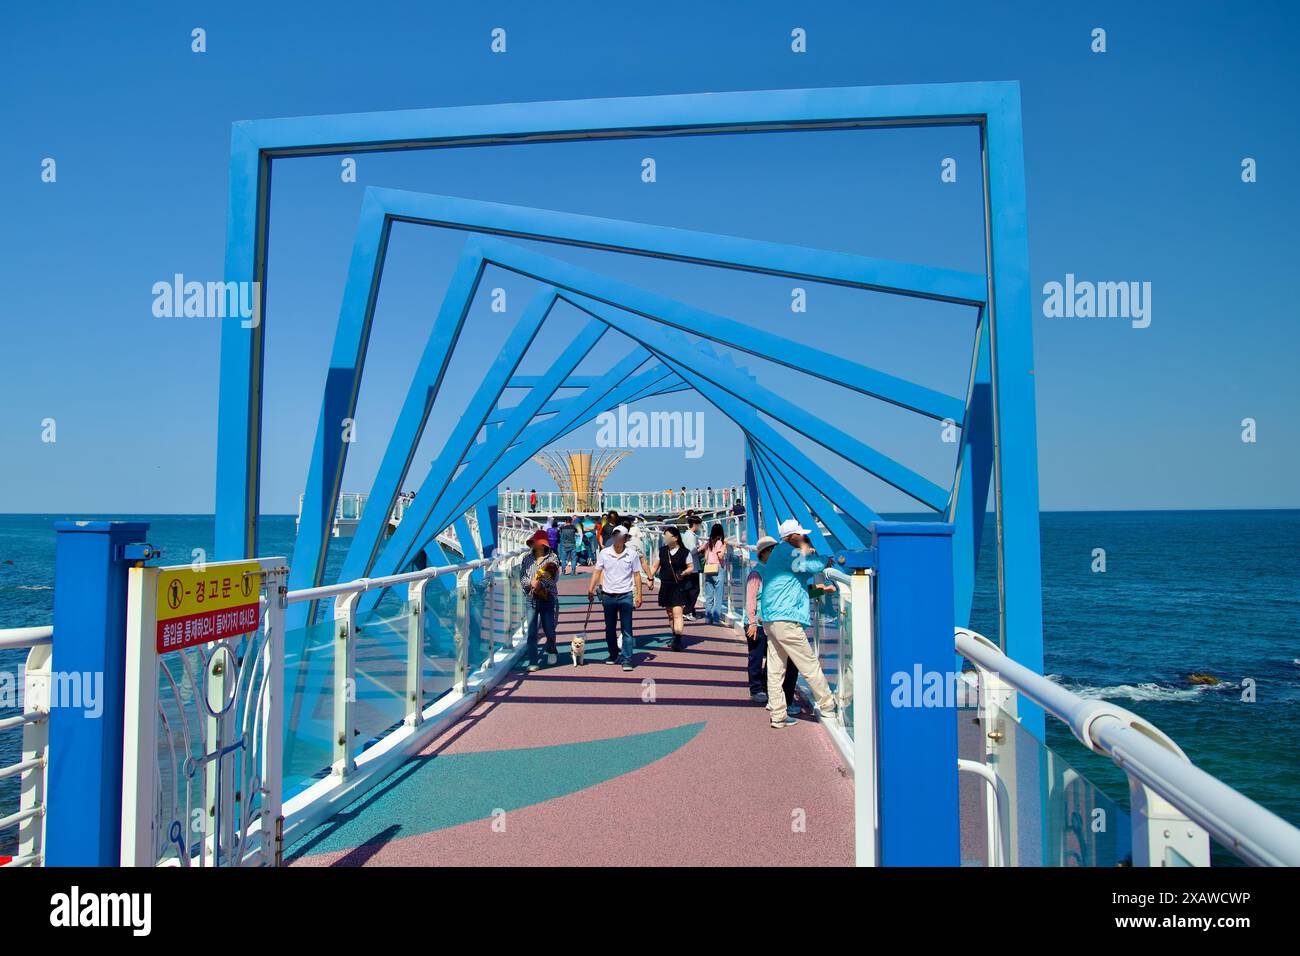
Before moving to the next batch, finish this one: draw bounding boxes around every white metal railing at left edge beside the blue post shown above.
[0,627,55,866]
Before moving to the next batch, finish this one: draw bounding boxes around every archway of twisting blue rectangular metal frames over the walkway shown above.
[216,83,1043,732]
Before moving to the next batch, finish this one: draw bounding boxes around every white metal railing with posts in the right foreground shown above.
[956,627,1300,866]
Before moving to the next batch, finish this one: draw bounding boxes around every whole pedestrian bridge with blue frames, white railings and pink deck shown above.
[0,83,1300,866]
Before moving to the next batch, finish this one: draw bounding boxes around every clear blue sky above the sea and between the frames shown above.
[0,3,1300,512]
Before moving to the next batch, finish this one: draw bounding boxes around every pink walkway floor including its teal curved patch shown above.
[290,575,853,866]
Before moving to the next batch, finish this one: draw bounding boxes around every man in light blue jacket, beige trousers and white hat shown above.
[758,518,836,730]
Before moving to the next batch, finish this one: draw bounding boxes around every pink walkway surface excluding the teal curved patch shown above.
[296,576,853,866]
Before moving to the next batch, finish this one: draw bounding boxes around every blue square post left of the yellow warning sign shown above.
[46,522,150,866]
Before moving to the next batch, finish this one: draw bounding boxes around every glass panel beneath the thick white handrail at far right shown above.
[957,695,1132,866]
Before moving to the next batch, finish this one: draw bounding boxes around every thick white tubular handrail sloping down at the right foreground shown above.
[956,627,1300,866]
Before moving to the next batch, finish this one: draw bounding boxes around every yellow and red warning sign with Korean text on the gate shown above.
[157,561,261,653]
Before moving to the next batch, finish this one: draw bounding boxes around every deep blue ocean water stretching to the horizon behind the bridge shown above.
[0,511,1300,864]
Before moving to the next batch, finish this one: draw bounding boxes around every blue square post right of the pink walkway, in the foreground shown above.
[871,522,961,866]
